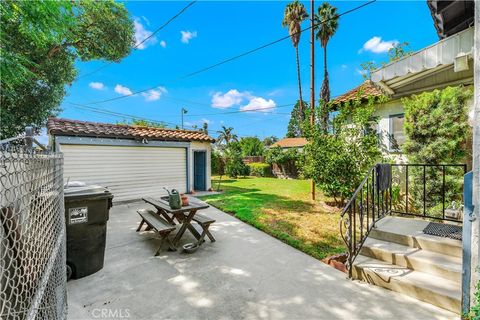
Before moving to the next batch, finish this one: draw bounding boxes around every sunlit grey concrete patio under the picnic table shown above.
[68,202,458,319]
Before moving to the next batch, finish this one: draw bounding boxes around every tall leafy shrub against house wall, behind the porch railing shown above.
[402,87,471,216]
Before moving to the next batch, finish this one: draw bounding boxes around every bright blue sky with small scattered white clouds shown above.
[60,1,438,138]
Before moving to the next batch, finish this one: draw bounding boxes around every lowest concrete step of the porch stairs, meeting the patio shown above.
[352,255,461,313]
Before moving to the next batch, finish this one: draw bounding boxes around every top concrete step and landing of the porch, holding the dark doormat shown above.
[369,217,462,258]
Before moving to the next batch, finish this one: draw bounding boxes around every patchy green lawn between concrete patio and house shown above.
[202,177,345,259]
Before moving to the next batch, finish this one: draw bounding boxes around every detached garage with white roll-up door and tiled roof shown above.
[47,118,214,202]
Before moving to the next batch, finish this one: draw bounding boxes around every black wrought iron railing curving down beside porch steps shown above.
[340,164,467,277]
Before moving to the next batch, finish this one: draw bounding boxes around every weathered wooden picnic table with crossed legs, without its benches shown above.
[142,198,209,247]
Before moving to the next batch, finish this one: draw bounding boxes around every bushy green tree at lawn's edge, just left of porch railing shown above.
[304,98,382,205]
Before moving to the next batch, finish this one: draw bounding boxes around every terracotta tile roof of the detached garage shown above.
[47,118,215,142]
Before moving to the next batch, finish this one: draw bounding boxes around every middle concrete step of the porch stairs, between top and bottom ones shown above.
[361,238,462,286]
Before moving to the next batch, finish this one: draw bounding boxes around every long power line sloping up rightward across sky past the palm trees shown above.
[73,0,376,104]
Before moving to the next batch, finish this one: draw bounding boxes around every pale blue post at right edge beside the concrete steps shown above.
[462,171,476,314]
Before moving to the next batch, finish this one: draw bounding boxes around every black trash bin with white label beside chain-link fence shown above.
[64,186,113,279]
